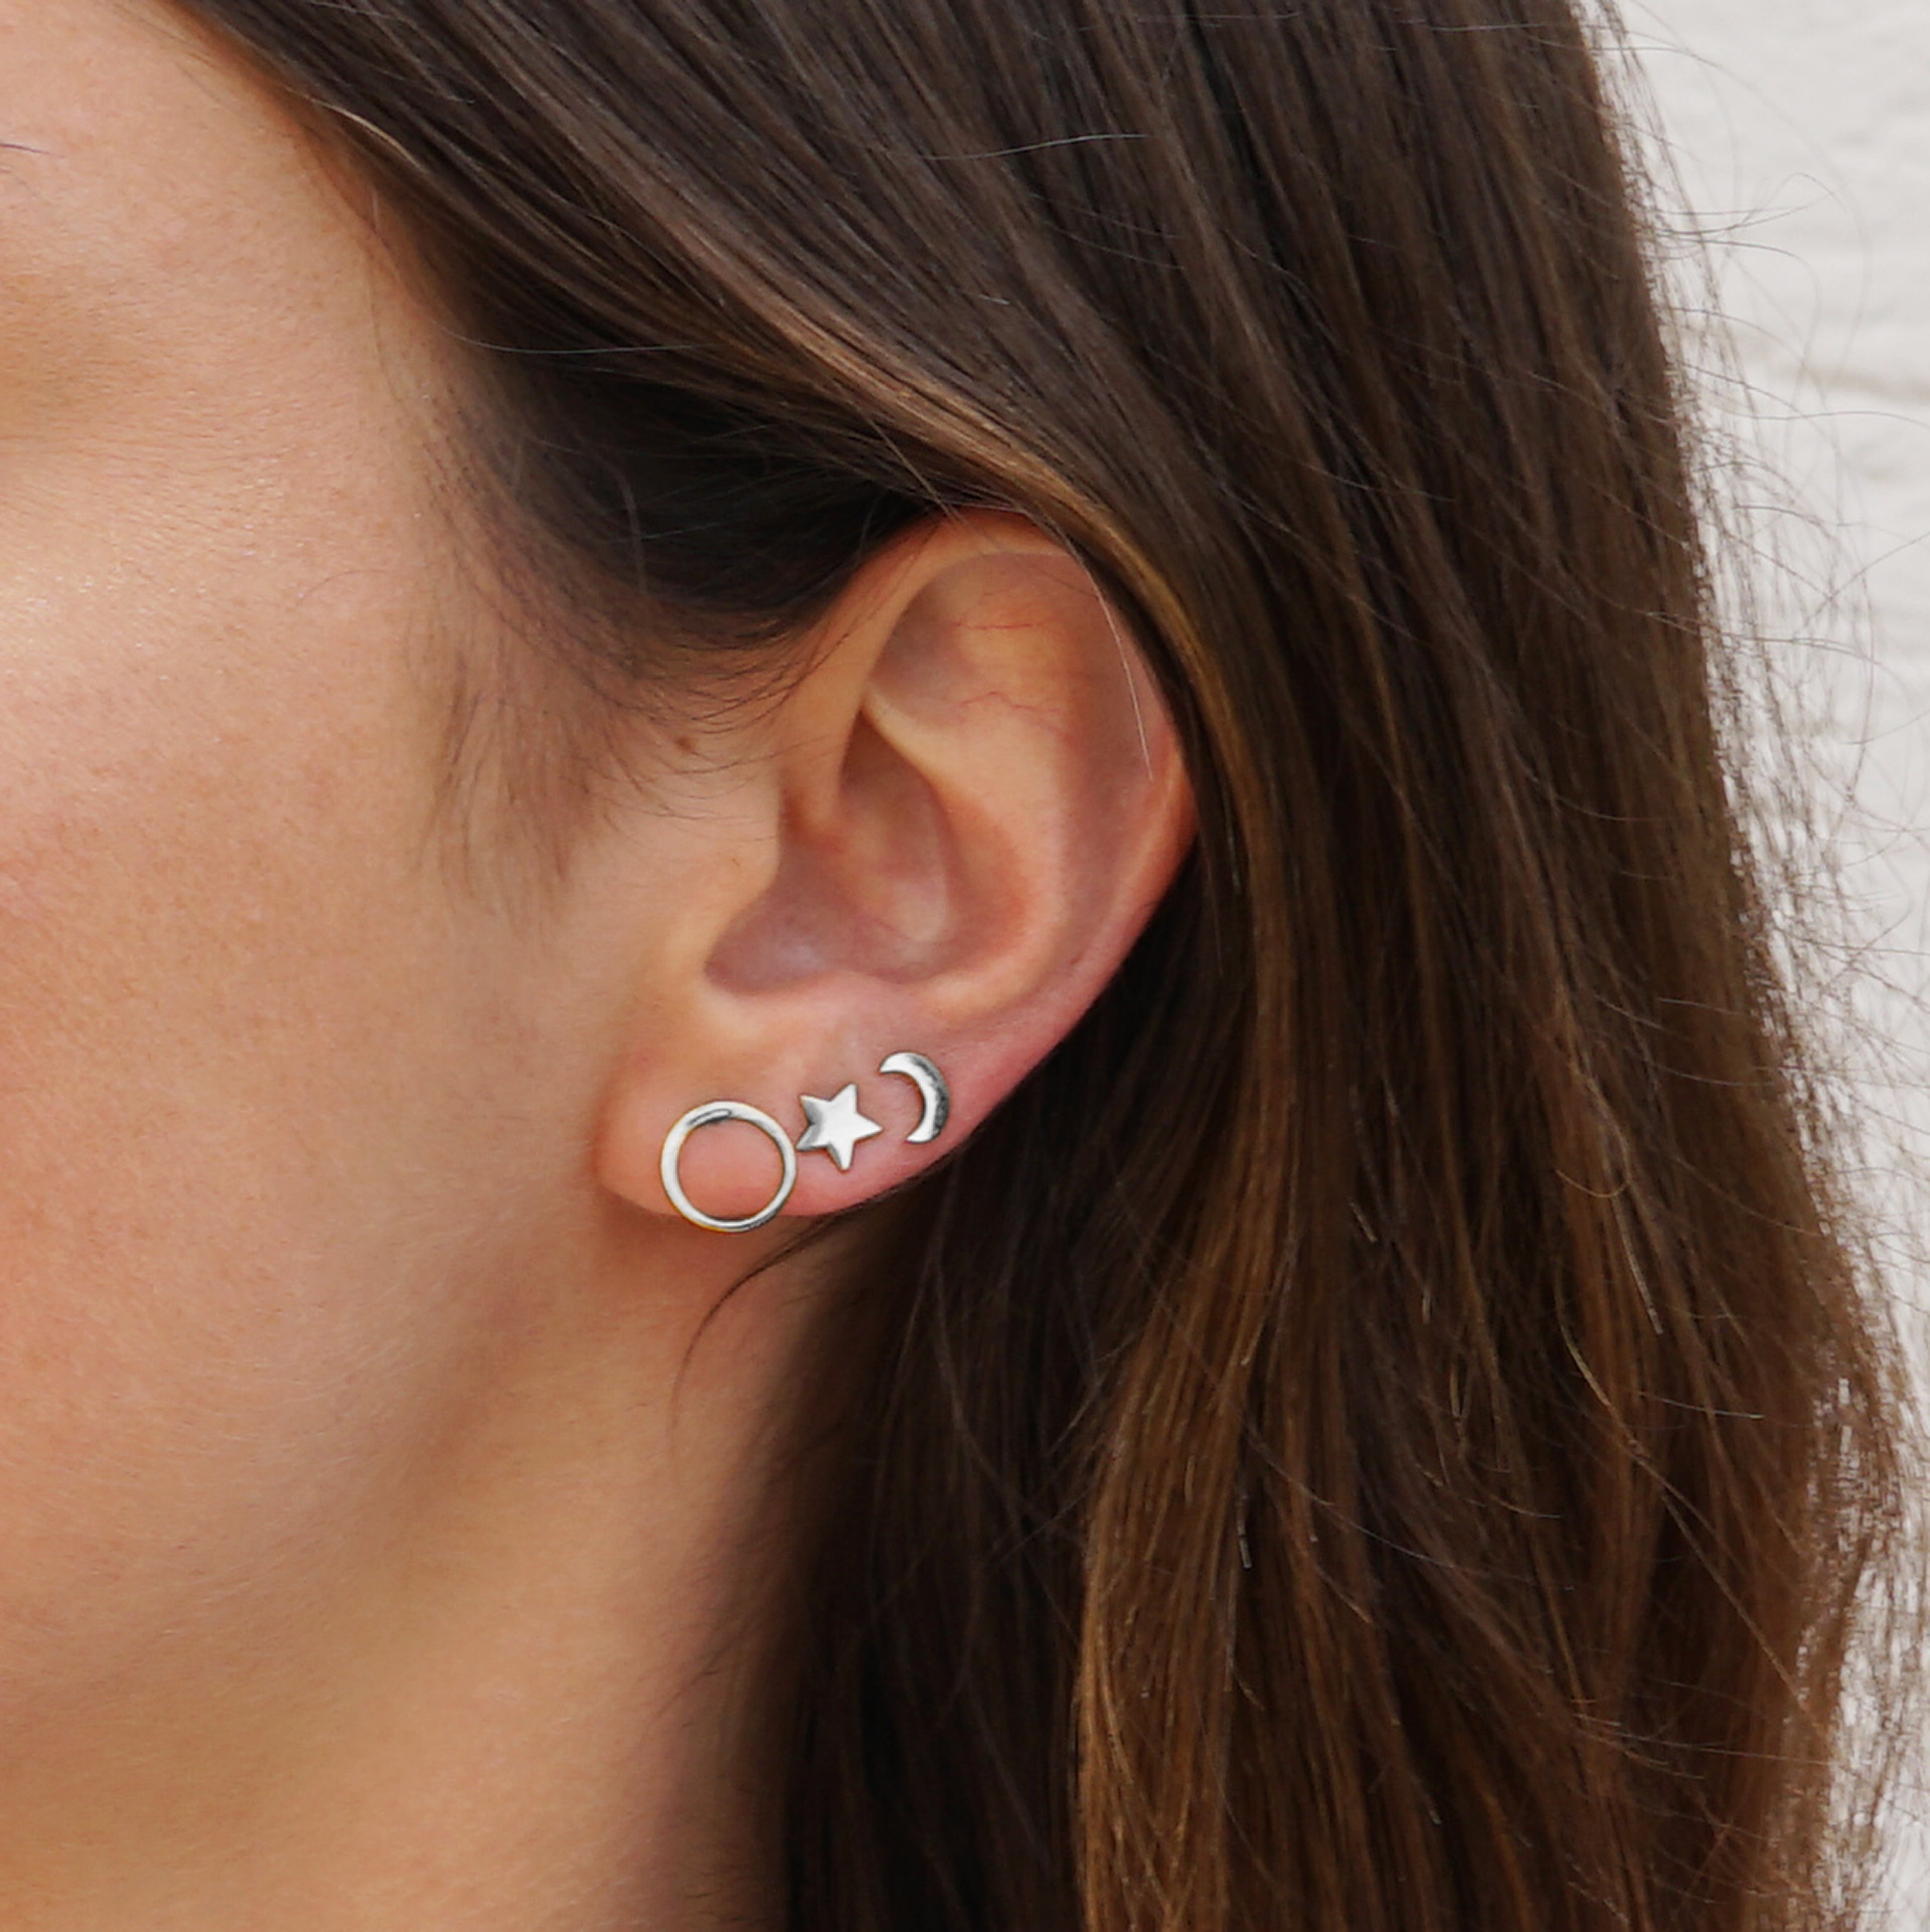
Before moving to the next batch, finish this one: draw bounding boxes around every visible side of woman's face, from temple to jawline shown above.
[0,0,560,1692]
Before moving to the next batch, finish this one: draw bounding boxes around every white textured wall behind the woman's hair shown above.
[1625,0,1930,1908]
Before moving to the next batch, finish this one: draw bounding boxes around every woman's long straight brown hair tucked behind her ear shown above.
[173,0,1899,1932]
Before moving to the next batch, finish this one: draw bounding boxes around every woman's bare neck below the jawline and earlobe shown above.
[0,1221,830,1932]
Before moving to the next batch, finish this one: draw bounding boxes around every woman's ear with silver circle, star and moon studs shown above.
[597,512,1192,1219]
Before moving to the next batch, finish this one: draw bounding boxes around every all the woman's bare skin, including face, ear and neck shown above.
[0,0,1188,1932]
